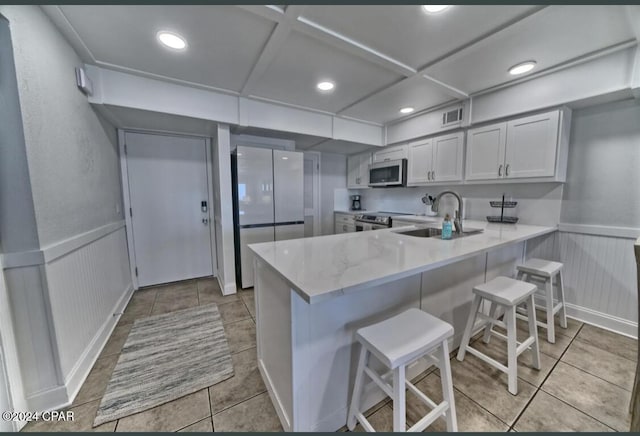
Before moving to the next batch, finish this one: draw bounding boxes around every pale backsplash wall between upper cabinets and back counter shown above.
[348,183,563,225]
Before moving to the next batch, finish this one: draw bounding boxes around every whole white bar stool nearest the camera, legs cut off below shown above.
[347,308,458,432]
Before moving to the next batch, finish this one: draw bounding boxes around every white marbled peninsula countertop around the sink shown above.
[249,217,557,303]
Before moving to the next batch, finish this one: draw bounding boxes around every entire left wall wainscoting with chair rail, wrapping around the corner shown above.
[3,221,133,410]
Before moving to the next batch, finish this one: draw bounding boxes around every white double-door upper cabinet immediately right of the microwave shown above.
[407,132,464,185]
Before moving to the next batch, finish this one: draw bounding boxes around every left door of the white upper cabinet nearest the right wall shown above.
[462,123,507,180]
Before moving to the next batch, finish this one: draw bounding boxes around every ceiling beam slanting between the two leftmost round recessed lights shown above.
[240,5,305,96]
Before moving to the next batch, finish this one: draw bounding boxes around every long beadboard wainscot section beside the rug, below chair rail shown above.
[46,226,133,398]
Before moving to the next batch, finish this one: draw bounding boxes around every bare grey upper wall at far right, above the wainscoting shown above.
[562,100,640,228]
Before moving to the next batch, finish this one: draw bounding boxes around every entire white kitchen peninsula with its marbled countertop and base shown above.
[250,220,556,431]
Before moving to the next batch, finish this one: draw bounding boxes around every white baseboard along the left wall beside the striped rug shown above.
[64,283,133,404]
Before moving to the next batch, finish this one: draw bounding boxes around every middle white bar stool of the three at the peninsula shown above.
[457,277,540,395]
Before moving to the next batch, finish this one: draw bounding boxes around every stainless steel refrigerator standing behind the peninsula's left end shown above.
[231,146,304,289]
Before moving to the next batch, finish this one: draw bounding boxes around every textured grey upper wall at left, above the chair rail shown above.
[0,6,122,246]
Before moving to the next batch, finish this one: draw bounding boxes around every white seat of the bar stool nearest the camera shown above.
[356,306,456,369]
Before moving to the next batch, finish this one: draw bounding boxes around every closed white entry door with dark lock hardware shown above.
[125,132,213,286]
